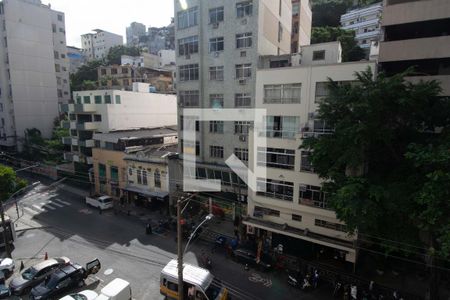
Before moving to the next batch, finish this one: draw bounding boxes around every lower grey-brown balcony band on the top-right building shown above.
[379,36,450,62]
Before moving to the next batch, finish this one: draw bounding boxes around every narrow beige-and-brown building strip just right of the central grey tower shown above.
[291,0,312,53]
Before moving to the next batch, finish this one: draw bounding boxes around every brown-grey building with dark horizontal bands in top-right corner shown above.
[379,0,450,96]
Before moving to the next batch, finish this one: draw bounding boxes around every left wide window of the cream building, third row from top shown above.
[257,147,295,170]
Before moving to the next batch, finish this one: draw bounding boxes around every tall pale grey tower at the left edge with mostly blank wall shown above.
[0,0,70,150]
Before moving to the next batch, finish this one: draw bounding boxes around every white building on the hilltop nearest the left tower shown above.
[81,29,123,60]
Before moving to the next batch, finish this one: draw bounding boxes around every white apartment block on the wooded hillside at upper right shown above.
[341,2,383,51]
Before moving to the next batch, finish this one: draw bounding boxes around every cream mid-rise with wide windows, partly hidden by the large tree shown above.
[243,42,376,262]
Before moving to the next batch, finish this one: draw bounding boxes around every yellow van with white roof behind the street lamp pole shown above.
[159,259,229,300]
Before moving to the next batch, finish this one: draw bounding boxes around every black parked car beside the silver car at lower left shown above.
[30,259,100,300]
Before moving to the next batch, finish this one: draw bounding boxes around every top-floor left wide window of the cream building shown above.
[264,83,302,104]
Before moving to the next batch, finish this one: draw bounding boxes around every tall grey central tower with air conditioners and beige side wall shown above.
[174,0,292,206]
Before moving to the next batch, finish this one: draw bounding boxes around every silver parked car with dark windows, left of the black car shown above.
[9,256,70,296]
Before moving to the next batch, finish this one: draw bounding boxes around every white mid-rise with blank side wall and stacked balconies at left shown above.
[60,83,177,164]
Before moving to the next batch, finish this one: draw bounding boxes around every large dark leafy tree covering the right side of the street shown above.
[301,70,450,299]
